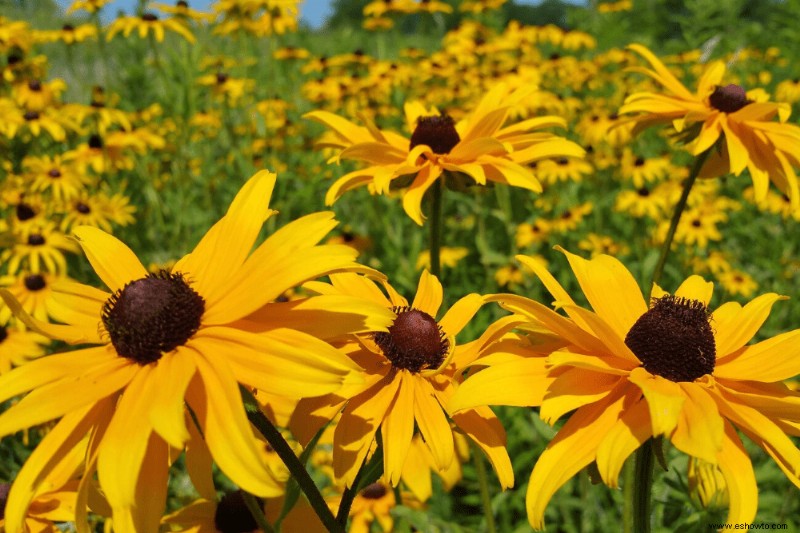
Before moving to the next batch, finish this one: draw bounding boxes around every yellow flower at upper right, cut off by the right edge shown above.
[619,44,800,210]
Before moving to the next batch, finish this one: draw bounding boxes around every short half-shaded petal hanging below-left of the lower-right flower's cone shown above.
[597,399,653,489]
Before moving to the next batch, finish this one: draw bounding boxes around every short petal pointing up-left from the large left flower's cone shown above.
[72,226,147,292]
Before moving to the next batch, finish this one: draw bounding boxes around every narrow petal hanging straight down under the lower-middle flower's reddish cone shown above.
[381,370,416,486]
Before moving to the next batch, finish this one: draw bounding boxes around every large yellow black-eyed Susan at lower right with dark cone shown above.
[451,250,800,529]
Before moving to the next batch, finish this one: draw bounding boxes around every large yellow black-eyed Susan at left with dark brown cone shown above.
[0,171,374,532]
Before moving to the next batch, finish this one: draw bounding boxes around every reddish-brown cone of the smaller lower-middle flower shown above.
[374,307,449,372]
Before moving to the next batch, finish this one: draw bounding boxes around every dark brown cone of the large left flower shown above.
[103,270,205,365]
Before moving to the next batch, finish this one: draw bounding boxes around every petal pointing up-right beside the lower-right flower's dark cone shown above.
[711,293,786,360]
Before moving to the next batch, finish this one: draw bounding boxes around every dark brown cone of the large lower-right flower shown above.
[625,295,717,382]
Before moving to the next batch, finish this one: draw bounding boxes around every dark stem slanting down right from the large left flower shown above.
[239,387,344,533]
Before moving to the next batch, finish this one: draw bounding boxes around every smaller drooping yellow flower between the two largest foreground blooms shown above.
[291,271,513,488]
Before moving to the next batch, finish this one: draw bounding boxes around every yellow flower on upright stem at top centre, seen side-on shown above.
[305,84,584,225]
